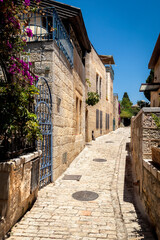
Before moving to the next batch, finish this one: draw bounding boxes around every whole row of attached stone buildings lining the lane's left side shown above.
[27,0,117,186]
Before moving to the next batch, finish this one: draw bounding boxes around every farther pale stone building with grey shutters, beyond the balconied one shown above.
[85,49,114,142]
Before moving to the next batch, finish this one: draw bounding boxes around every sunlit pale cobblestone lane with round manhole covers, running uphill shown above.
[8,128,154,240]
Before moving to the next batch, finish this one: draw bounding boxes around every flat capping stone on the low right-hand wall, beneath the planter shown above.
[143,159,160,181]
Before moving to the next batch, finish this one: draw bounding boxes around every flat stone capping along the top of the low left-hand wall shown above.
[0,150,42,172]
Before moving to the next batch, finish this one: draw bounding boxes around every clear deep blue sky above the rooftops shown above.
[59,0,160,104]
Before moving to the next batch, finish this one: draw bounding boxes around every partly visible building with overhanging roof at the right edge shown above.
[140,35,160,107]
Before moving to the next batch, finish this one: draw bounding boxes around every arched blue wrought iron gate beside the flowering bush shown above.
[35,77,52,188]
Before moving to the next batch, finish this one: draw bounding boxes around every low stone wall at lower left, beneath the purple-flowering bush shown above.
[0,152,41,239]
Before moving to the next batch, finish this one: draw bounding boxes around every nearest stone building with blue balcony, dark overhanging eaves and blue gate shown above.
[27,1,91,186]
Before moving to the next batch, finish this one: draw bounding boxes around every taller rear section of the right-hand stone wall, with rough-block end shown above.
[131,108,160,182]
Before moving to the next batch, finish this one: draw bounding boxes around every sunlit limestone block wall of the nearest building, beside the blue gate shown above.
[28,41,85,180]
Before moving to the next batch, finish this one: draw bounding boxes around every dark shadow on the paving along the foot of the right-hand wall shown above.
[123,143,158,240]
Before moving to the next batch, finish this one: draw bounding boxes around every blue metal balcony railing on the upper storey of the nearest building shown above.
[23,7,73,67]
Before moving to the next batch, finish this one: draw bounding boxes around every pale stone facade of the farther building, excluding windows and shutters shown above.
[85,48,113,142]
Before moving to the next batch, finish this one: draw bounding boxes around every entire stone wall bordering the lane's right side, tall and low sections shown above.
[131,108,160,239]
